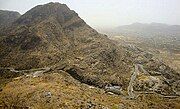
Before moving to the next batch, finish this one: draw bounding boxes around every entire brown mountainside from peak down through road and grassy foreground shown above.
[0,3,180,109]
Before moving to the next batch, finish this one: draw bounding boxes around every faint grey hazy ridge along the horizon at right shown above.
[114,23,180,39]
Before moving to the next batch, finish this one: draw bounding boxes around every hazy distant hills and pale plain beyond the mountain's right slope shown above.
[107,23,180,53]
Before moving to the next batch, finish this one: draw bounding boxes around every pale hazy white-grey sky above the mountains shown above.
[0,0,180,28]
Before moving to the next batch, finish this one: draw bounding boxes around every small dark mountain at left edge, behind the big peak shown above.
[0,10,21,29]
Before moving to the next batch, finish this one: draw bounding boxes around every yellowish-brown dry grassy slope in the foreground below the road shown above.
[0,71,179,109]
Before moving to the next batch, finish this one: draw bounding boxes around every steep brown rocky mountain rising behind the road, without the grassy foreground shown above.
[0,3,130,87]
